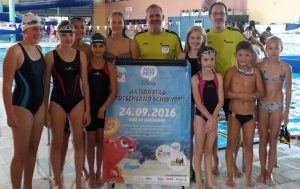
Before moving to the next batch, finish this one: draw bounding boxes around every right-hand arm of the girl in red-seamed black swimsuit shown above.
[80,51,91,126]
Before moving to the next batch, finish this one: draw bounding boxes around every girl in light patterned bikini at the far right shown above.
[256,36,292,184]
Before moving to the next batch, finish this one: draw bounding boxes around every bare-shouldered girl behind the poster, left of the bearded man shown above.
[104,12,139,62]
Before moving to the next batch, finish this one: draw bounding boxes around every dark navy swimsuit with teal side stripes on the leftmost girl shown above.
[12,43,46,114]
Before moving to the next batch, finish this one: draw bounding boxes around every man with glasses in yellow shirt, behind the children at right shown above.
[206,2,247,185]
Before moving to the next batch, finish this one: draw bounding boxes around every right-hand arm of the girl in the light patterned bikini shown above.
[282,63,292,125]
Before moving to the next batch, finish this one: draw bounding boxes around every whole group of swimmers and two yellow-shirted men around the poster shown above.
[3,2,291,189]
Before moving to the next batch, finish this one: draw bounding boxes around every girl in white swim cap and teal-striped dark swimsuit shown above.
[3,12,46,188]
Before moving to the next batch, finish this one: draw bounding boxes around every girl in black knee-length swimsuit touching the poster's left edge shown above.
[85,33,117,188]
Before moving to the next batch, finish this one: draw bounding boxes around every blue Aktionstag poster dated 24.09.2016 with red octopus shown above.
[103,61,191,186]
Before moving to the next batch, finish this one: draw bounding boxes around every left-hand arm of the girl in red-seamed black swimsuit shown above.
[44,51,54,127]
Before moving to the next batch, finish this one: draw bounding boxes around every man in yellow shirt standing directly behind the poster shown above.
[135,4,182,59]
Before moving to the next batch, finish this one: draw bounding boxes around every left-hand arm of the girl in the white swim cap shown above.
[2,46,21,127]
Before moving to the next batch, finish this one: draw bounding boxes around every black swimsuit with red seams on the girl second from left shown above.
[51,50,83,113]
